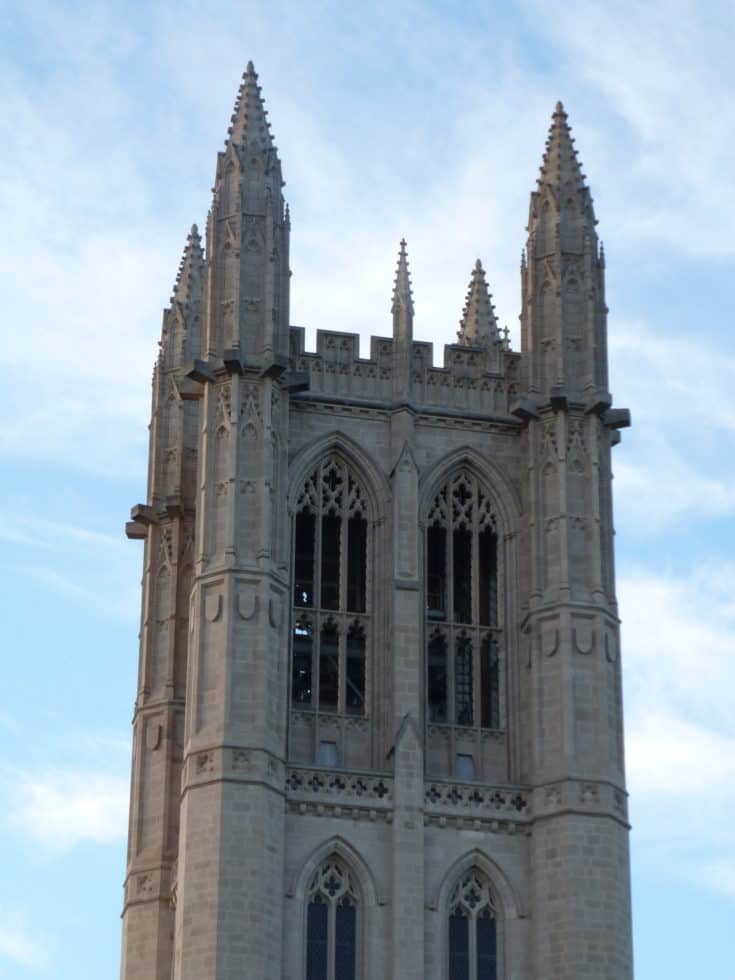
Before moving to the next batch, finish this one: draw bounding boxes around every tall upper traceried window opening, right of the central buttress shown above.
[426,470,502,729]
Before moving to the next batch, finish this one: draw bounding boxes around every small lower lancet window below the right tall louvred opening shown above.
[449,868,498,980]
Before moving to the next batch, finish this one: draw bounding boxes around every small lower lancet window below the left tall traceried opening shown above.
[306,859,358,980]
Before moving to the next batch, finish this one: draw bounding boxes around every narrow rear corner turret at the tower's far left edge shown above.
[121,226,204,980]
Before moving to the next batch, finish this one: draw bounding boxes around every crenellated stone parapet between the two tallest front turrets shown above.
[290,327,521,416]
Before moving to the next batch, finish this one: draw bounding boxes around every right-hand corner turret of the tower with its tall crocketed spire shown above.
[515,104,632,980]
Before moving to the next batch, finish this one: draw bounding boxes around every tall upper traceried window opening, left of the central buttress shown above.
[291,454,370,715]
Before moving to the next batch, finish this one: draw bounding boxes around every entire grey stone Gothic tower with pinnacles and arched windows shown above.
[121,64,632,980]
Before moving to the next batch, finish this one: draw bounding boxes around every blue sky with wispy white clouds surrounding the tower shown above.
[0,0,735,980]
